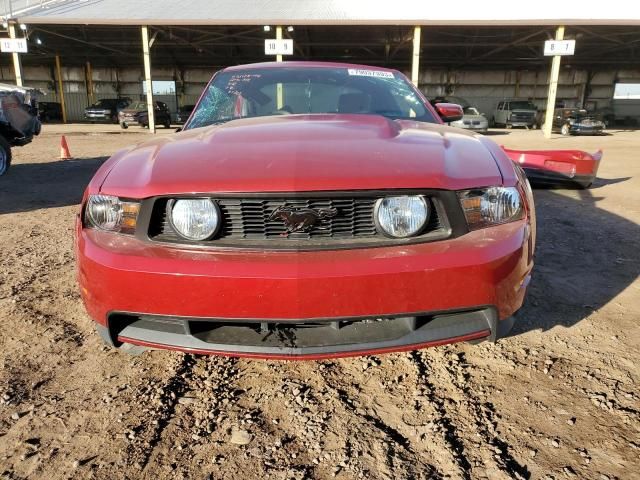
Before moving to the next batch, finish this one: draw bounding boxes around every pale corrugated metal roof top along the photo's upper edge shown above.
[0,0,640,25]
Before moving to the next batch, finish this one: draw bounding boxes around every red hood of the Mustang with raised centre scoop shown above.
[101,114,502,198]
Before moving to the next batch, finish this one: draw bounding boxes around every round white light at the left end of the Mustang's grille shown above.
[169,198,220,241]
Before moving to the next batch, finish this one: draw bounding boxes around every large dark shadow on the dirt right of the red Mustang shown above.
[512,186,640,335]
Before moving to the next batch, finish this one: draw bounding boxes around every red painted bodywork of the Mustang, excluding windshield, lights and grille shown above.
[76,63,535,359]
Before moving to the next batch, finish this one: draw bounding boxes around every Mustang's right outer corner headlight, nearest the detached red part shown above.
[458,187,524,230]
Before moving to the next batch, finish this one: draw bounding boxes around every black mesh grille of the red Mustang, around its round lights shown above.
[148,195,450,248]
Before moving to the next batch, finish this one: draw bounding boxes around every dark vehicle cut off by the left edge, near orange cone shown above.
[0,83,42,176]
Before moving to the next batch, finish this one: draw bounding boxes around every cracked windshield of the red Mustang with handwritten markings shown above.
[186,67,438,129]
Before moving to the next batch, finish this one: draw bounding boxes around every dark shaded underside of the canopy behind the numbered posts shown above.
[17,24,640,70]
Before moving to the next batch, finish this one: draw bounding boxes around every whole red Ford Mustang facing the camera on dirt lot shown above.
[76,62,535,358]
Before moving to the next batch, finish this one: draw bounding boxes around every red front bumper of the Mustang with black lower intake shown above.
[76,221,532,358]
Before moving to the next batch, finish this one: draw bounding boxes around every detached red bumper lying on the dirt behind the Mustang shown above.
[503,147,602,188]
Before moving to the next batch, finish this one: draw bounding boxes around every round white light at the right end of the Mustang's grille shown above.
[374,195,429,238]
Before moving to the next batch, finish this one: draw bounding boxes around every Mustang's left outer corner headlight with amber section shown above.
[84,195,140,233]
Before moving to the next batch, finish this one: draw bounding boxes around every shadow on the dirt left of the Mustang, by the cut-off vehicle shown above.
[0,157,108,215]
